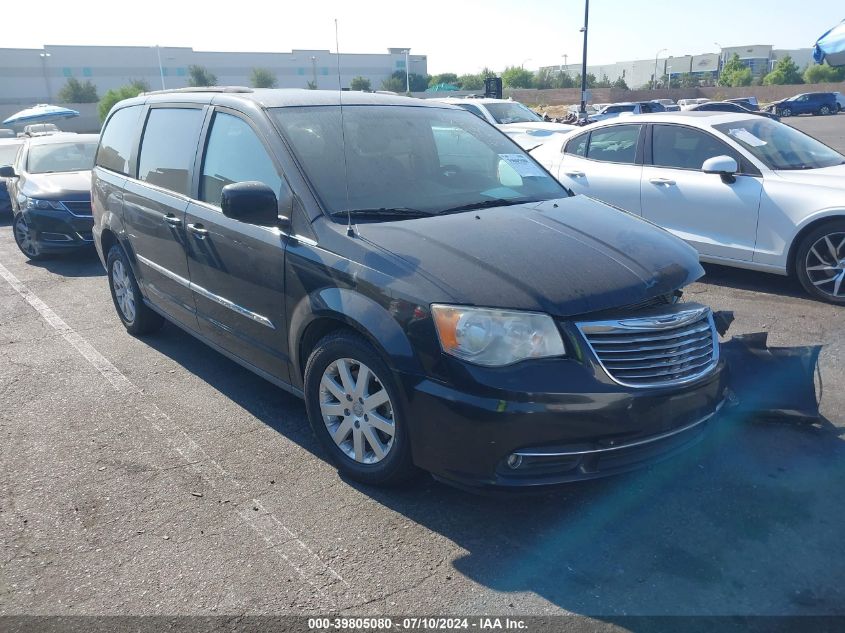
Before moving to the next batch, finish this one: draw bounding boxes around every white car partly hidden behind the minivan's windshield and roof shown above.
[431,97,579,149]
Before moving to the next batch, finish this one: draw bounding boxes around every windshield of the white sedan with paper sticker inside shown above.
[713,118,845,169]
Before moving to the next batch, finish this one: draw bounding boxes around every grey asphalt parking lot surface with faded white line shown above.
[0,116,845,619]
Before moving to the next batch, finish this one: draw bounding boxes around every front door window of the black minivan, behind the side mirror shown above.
[200,112,282,207]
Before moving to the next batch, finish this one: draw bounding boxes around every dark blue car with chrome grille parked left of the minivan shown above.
[0,133,99,259]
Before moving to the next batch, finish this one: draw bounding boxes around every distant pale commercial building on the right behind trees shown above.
[541,44,814,88]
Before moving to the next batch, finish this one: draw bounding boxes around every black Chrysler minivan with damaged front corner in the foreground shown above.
[92,88,726,488]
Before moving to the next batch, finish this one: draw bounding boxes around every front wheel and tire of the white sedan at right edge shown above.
[795,220,845,305]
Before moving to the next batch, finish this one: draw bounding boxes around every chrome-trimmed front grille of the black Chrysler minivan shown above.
[577,306,719,387]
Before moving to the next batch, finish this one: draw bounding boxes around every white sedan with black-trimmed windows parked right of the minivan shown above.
[532,112,845,305]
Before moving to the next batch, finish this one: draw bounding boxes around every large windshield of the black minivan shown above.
[271,105,567,216]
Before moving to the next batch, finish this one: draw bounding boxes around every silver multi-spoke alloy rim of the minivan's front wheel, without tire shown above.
[320,358,396,464]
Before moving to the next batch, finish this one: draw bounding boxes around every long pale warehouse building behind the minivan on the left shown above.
[0,45,428,104]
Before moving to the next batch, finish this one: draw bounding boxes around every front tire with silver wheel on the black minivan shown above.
[305,331,418,486]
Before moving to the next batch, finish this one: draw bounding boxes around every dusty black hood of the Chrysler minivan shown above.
[358,196,704,317]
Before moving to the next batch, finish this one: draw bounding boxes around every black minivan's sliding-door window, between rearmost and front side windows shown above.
[138,108,203,196]
